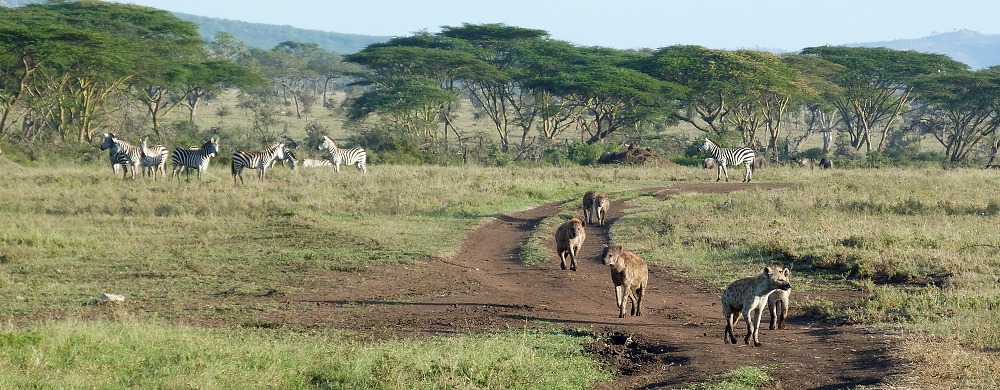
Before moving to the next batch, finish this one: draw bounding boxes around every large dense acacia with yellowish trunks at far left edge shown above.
[0,1,220,142]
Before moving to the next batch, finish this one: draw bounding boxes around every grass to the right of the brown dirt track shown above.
[611,168,1000,387]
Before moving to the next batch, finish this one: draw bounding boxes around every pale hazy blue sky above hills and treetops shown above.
[109,0,1000,51]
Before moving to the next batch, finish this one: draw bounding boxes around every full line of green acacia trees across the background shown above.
[0,0,1000,164]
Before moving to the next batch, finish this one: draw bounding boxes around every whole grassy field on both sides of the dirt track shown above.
[0,158,1000,388]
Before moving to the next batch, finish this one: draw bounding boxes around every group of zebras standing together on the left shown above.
[101,133,368,183]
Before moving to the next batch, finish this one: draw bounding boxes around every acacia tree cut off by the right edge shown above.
[913,67,1000,163]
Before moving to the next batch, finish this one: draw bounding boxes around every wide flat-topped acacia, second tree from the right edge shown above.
[802,46,968,152]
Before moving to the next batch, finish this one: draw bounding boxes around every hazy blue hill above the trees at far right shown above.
[844,30,1000,69]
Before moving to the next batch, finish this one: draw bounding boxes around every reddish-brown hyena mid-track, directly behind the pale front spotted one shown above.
[601,245,649,318]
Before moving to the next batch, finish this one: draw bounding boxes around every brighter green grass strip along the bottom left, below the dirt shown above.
[0,320,610,389]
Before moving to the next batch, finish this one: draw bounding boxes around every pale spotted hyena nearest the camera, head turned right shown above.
[722,267,792,347]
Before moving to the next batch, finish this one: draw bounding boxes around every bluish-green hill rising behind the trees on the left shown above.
[174,12,391,54]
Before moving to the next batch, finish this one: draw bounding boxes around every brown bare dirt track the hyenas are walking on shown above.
[269,183,903,389]
